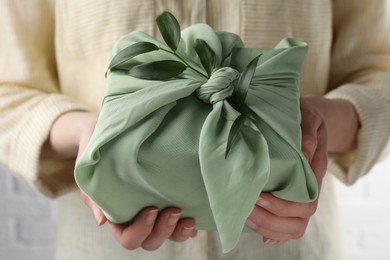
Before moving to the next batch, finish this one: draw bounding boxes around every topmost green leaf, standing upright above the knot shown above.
[156,12,181,51]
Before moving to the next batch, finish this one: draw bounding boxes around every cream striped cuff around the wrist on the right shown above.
[326,84,390,185]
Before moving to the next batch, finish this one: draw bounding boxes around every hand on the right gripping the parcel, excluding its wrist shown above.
[246,95,328,244]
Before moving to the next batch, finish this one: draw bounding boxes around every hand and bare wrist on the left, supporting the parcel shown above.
[41,112,197,250]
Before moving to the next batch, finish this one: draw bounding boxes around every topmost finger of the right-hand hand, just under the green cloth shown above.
[256,193,318,218]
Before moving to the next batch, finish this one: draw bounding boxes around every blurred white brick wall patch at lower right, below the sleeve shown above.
[337,154,390,260]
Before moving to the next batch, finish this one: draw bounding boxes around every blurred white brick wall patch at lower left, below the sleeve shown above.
[0,168,55,260]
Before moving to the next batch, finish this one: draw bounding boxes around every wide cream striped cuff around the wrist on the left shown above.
[8,94,86,197]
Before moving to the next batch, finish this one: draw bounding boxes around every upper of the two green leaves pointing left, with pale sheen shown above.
[107,42,159,70]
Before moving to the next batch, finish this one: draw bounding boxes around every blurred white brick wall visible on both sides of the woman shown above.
[0,155,390,260]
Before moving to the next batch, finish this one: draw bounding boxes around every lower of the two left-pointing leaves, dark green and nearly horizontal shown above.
[129,60,187,80]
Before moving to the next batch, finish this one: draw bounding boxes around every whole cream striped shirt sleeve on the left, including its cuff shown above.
[0,0,85,196]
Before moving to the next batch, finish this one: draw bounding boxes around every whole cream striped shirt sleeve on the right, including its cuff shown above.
[327,0,390,184]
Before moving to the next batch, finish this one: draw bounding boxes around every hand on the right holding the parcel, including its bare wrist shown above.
[246,96,359,244]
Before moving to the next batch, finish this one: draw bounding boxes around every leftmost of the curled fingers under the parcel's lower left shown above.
[109,208,158,250]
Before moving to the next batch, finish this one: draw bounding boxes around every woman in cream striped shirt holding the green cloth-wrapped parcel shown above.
[0,0,390,259]
